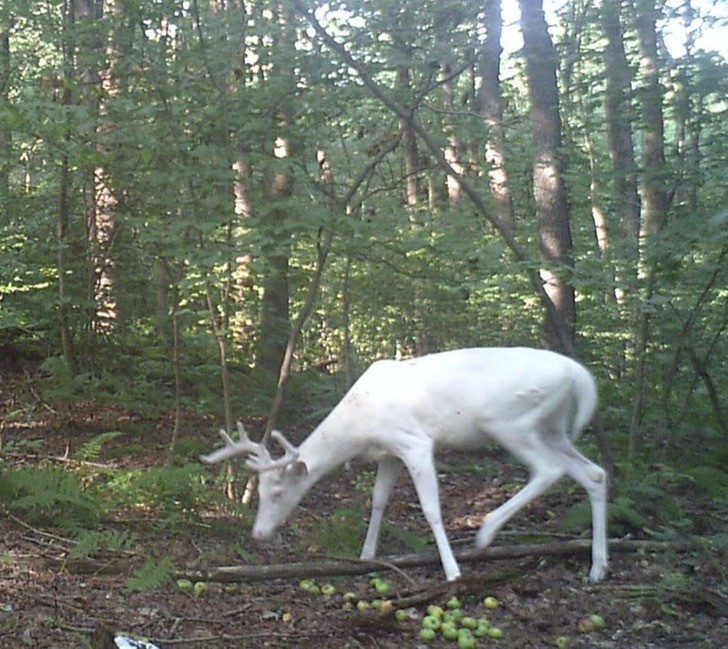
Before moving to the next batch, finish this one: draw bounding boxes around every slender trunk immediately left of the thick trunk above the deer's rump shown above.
[479,0,515,231]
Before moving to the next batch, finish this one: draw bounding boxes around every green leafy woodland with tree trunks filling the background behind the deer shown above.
[0,0,728,588]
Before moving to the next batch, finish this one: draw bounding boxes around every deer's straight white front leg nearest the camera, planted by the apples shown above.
[404,448,461,581]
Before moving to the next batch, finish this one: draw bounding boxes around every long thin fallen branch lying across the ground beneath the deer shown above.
[176,540,689,583]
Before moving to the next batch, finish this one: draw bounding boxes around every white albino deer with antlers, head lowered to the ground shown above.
[201,347,607,582]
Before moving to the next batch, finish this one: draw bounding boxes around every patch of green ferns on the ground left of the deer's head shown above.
[0,431,235,557]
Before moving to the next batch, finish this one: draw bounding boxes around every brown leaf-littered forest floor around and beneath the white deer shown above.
[0,368,728,649]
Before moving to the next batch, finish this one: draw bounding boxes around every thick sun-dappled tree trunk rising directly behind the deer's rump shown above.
[520,0,576,351]
